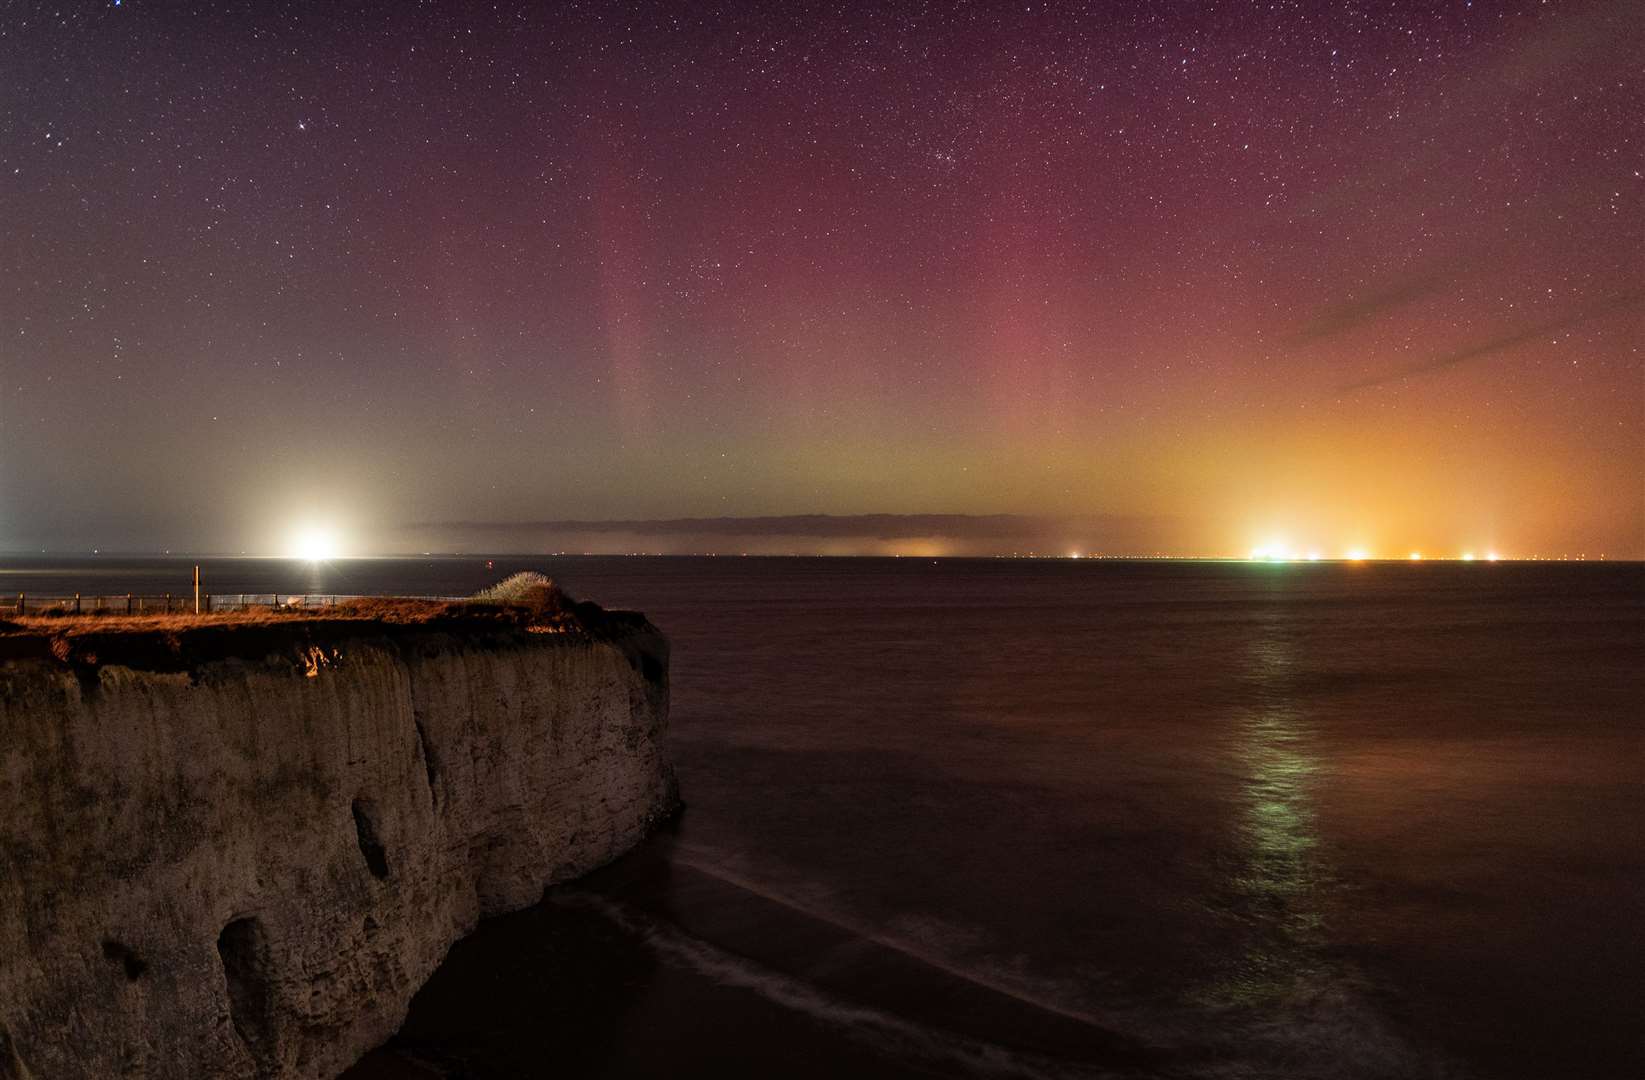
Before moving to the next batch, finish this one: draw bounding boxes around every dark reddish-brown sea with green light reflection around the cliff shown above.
[0,557,1645,1078]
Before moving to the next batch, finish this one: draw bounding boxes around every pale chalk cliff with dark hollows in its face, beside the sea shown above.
[0,616,678,1080]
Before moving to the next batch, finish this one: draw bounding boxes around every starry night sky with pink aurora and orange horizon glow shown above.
[0,0,1645,557]
